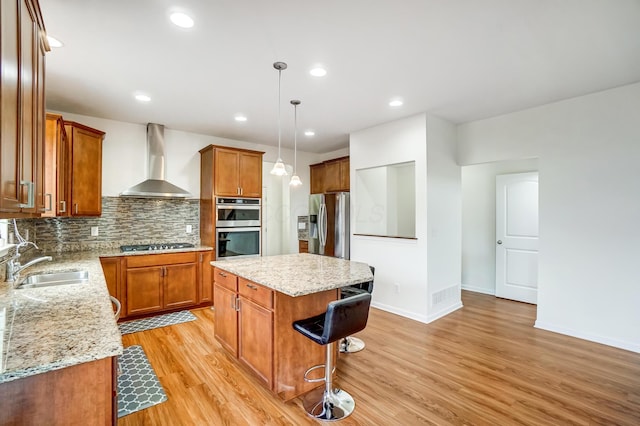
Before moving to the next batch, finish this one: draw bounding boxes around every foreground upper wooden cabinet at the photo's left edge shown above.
[0,0,49,217]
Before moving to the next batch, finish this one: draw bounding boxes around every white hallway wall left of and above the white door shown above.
[462,159,538,295]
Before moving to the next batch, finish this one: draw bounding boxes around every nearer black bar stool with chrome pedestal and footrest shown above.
[293,293,371,420]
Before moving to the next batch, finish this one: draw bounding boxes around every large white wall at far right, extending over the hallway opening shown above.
[458,83,640,352]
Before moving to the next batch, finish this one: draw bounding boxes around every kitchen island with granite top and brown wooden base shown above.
[211,253,373,401]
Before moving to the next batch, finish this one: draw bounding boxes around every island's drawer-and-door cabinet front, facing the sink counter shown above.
[214,268,274,389]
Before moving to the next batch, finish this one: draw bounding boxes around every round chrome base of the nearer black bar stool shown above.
[302,387,356,422]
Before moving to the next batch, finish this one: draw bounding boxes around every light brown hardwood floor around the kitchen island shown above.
[118,292,640,426]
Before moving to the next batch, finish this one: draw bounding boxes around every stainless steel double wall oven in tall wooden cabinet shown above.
[216,197,262,259]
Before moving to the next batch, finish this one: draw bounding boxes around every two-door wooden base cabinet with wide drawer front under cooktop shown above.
[122,252,199,316]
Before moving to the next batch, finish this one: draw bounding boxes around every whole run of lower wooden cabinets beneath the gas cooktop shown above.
[100,251,213,318]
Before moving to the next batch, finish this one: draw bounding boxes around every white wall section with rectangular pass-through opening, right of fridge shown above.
[349,114,461,322]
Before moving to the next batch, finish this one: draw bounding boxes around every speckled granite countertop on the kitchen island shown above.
[211,253,373,297]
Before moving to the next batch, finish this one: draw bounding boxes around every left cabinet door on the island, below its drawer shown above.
[213,284,238,356]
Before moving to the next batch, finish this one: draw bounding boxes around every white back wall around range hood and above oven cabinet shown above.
[58,112,320,253]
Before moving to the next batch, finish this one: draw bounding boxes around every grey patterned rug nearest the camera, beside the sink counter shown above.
[118,345,167,417]
